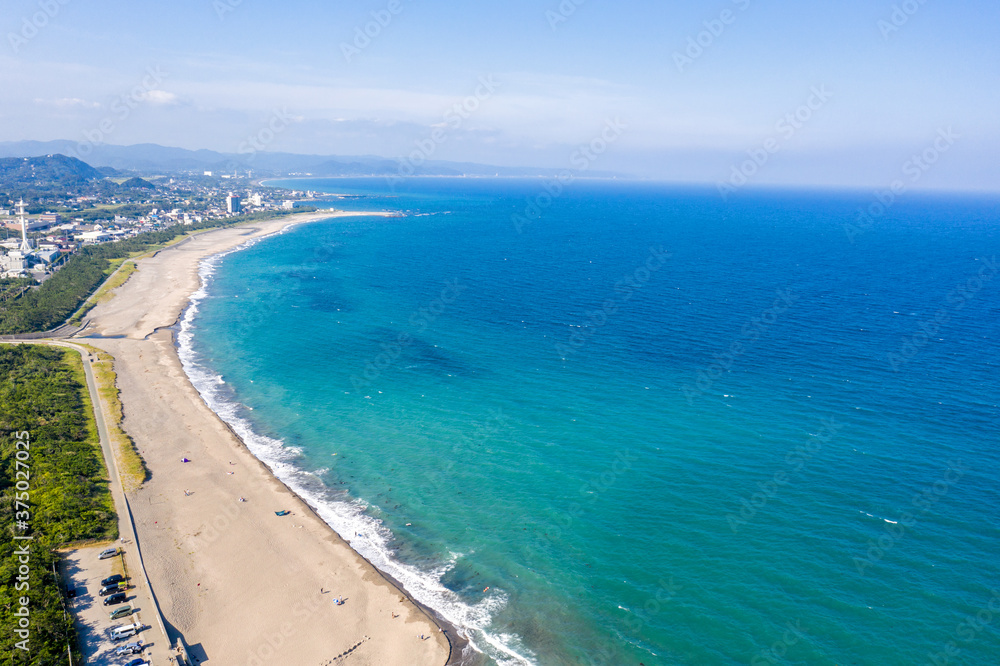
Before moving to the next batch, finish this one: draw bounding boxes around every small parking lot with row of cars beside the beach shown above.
[60,542,175,666]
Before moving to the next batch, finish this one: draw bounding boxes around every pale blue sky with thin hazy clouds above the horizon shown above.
[0,0,1000,190]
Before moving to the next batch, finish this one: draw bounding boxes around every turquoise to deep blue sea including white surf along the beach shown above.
[180,178,1000,666]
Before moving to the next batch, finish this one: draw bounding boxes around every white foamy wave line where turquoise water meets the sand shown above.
[177,230,536,666]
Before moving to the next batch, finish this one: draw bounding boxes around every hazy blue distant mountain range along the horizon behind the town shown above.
[0,140,624,178]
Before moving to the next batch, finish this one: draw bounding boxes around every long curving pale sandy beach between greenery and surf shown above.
[77,211,450,666]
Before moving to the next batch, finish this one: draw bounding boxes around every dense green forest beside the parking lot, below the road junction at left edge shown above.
[0,345,118,666]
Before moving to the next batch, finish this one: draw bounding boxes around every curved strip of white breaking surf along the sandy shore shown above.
[173,213,533,666]
